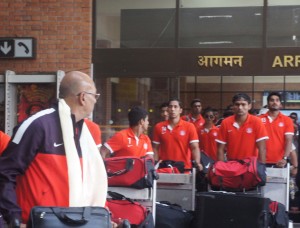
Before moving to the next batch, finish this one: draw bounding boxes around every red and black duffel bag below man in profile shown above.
[104,156,158,189]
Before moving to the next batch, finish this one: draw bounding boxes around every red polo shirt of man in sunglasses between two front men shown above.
[199,126,219,161]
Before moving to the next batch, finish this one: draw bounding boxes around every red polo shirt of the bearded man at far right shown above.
[259,112,294,163]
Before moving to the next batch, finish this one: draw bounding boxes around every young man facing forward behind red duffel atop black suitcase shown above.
[216,93,268,163]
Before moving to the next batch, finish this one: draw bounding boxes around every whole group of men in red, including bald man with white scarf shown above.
[0,71,298,227]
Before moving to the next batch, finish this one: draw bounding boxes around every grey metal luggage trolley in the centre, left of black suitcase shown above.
[156,168,196,210]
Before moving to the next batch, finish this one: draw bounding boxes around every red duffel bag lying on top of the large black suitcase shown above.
[208,157,266,191]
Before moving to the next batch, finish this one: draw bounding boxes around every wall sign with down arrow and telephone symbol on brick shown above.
[0,37,35,58]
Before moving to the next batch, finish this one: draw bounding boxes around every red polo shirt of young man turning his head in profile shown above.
[104,128,153,157]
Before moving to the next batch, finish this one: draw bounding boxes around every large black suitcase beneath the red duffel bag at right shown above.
[193,192,270,228]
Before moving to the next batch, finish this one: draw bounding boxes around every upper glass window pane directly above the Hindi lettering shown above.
[179,0,263,48]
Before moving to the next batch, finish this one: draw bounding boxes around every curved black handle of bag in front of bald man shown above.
[51,207,91,225]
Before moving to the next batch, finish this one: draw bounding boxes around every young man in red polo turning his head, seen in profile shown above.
[100,107,153,158]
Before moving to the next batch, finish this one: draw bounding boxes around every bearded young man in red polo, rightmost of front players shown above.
[259,92,294,167]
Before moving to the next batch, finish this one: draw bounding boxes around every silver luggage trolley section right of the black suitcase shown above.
[261,163,290,211]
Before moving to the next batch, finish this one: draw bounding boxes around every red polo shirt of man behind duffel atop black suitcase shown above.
[216,114,268,160]
